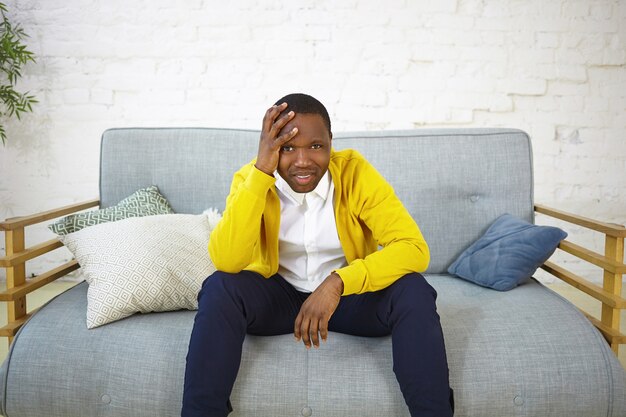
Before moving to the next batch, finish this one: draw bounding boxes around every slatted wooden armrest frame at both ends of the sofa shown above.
[0,199,626,355]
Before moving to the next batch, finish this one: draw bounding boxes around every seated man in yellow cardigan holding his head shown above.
[182,94,453,417]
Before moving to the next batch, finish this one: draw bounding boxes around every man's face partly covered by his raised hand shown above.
[278,113,332,193]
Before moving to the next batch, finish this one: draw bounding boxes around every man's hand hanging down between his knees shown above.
[293,272,343,349]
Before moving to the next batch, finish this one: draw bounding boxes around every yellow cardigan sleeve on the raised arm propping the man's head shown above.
[208,163,276,273]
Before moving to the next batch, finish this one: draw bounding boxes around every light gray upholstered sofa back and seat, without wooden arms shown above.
[0,128,626,417]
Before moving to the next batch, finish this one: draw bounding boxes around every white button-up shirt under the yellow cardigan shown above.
[275,171,347,292]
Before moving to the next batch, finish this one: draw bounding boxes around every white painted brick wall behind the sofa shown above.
[0,0,626,282]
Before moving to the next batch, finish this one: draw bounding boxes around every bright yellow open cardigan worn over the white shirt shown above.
[209,150,430,295]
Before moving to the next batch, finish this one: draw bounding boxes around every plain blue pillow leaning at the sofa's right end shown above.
[448,214,567,291]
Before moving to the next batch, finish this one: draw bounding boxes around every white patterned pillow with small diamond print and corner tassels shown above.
[59,211,220,329]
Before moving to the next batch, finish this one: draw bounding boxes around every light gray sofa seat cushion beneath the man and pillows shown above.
[0,275,626,417]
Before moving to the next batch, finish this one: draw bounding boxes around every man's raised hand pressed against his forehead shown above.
[254,103,298,175]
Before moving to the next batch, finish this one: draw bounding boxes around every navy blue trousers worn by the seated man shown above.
[182,271,453,417]
